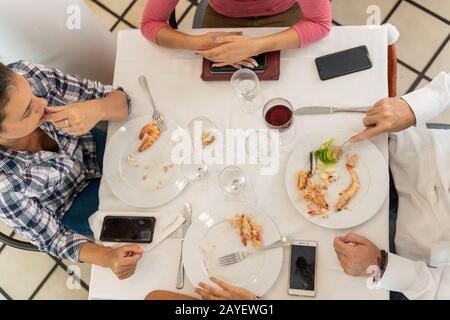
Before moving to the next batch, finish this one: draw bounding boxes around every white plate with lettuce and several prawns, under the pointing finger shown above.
[285,128,389,229]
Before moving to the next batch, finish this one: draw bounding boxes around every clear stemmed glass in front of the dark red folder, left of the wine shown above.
[231,68,263,113]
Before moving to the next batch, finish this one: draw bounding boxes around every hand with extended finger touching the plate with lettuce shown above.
[350,98,416,143]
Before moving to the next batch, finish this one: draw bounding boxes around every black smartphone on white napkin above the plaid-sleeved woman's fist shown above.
[100,216,156,243]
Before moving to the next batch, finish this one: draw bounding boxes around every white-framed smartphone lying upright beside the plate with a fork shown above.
[288,240,317,297]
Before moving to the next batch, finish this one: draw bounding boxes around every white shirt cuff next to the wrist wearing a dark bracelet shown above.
[379,253,416,292]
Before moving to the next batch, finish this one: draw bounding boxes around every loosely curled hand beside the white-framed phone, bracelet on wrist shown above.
[333,233,381,276]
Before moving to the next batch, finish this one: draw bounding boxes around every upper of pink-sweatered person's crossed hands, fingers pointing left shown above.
[196,35,259,67]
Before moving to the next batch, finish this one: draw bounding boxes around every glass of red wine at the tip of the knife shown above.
[263,98,295,145]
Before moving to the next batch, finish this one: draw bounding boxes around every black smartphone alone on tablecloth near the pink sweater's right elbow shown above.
[316,46,372,80]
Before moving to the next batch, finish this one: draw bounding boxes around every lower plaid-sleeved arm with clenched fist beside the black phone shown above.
[0,192,143,279]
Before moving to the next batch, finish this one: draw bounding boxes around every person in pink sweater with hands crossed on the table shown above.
[141,0,331,67]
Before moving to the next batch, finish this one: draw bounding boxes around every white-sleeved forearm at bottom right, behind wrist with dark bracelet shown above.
[380,253,450,300]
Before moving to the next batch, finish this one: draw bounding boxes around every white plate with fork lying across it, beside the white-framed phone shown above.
[183,202,283,296]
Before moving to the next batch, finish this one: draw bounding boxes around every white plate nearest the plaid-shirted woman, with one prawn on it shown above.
[103,116,187,208]
